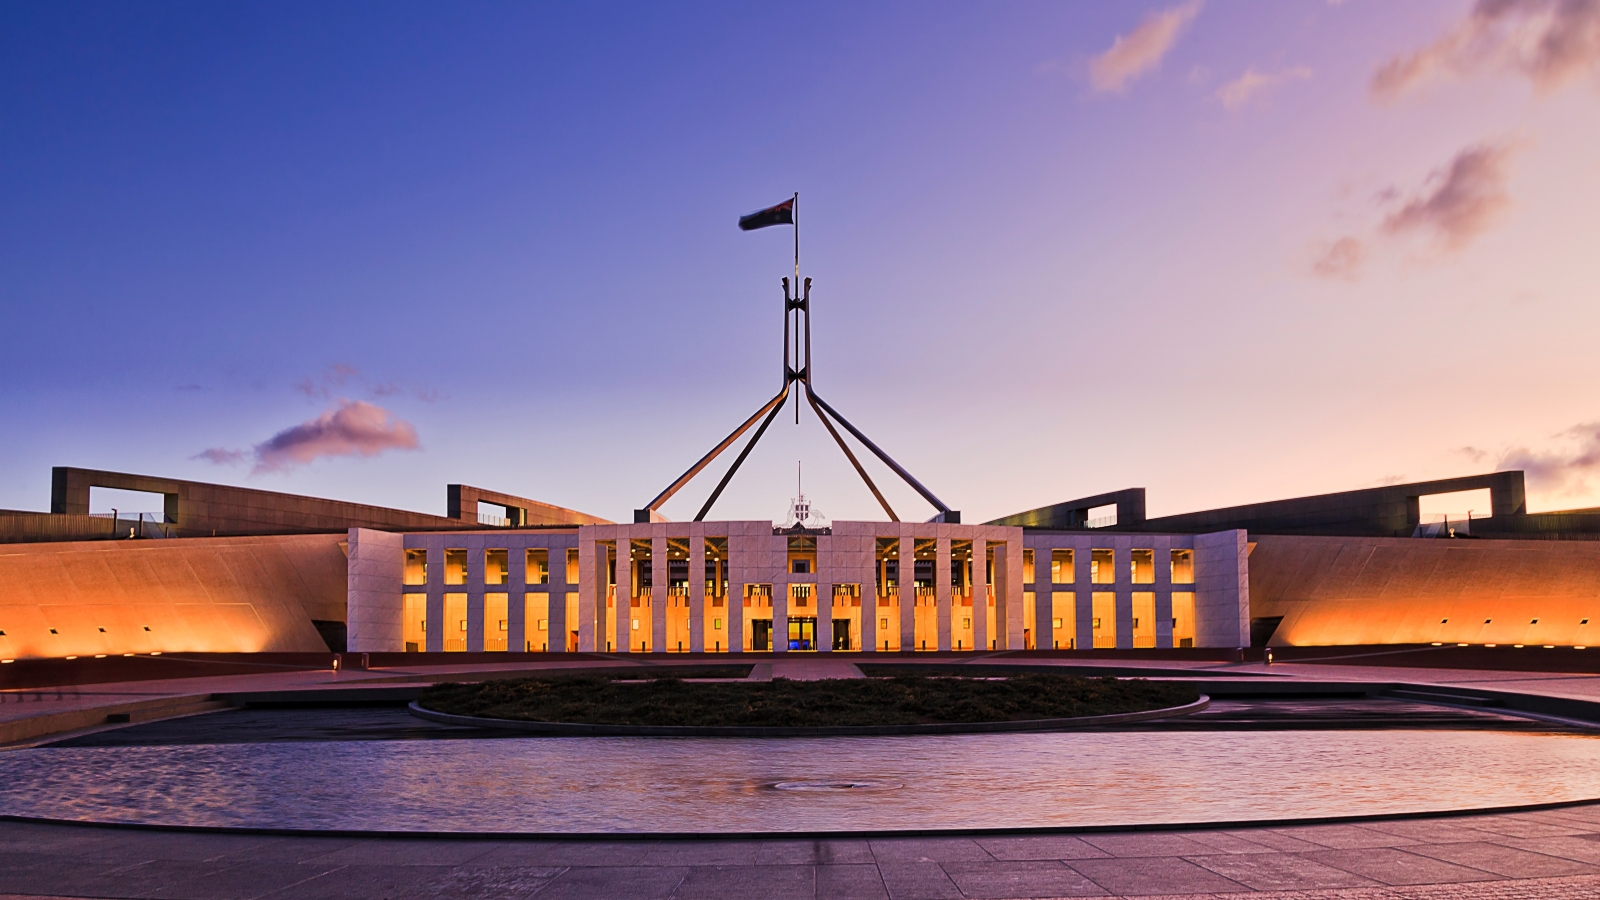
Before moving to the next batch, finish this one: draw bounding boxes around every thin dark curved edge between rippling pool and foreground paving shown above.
[0,798,1600,841]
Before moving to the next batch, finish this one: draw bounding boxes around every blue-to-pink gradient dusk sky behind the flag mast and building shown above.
[0,0,1600,520]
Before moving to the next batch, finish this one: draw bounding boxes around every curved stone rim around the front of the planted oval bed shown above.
[408,693,1211,738]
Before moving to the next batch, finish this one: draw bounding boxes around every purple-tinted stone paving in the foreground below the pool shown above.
[0,804,1600,900]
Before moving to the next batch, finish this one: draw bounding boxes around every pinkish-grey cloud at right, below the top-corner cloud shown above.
[1382,144,1512,250]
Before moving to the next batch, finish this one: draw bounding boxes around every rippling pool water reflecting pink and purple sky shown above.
[0,730,1600,833]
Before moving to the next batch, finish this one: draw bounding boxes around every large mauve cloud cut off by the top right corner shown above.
[1371,0,1600,101]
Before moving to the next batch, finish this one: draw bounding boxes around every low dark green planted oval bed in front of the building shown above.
[421,674,1200,727]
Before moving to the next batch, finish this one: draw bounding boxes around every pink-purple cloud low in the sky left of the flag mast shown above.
[194,399,421,474]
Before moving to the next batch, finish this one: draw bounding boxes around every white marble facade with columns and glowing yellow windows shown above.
[349,520,1250,653]
